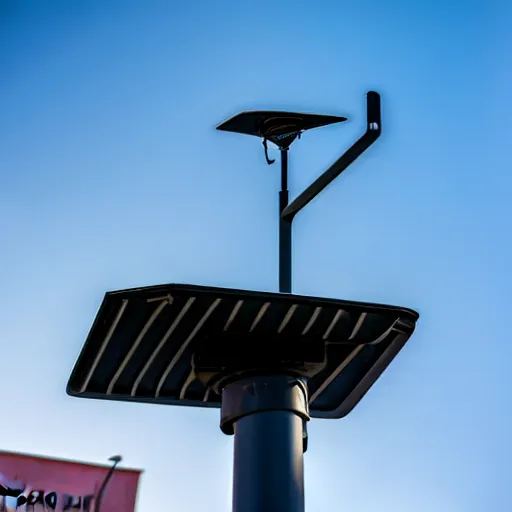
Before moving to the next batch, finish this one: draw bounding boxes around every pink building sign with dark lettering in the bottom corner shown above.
[0,451,141,512]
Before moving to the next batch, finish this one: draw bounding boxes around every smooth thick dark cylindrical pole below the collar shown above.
[233,411,304,512]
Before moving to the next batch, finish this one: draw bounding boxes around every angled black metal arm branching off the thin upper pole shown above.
[281,91,381,222]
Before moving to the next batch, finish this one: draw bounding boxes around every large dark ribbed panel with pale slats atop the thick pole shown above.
[67,284,418,418]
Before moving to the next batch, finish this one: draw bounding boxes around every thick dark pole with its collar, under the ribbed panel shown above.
[221,375,309,512]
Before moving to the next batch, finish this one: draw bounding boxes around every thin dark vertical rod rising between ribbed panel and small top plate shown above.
[279,148,292,293]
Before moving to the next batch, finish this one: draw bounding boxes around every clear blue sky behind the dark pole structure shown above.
[0,0,512,512]
